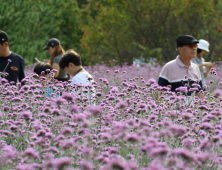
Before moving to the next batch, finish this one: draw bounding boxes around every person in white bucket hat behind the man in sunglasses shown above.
[191,39,214,87]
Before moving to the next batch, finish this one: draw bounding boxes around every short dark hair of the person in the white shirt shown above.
[59,50,82,69]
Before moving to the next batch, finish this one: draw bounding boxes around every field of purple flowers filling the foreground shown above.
[0,63,222,170]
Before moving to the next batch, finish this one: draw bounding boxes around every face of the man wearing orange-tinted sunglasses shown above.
[179,44,197,59]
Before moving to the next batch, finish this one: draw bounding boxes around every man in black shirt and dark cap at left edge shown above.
[0,30,25,84]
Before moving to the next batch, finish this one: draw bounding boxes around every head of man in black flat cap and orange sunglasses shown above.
[176,35,199,60]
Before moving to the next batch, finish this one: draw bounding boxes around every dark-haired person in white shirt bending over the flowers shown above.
[59,50,95,101]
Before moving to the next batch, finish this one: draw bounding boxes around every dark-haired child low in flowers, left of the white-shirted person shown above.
[34,63,59,97]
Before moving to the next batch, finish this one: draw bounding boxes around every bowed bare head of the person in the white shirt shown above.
[59,50,82,76]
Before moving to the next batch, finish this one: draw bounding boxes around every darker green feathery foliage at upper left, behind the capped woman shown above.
[0,0,82,64]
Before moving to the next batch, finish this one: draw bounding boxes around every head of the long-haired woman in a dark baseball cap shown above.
[43,38,65,65]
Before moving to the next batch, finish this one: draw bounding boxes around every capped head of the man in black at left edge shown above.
[0,30,9,57]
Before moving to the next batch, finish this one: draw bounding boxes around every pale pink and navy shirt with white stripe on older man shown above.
[158,56,202,95]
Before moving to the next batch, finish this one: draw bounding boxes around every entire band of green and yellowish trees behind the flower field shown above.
[0,0,222,65]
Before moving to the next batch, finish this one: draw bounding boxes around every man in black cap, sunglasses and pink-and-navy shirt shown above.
[158,35,203,98]
